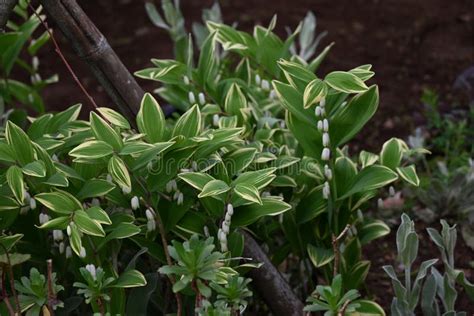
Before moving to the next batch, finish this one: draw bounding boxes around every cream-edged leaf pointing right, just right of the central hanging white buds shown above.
[232,197,291,227]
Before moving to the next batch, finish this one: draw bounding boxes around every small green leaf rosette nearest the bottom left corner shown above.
[15,268,64,316]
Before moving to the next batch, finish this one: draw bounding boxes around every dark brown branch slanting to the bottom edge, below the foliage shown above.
[242,232,304,316]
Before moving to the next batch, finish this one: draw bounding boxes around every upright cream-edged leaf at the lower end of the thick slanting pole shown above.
[137,93,166,143]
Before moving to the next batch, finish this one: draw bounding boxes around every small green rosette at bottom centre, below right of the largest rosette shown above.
[210,275,252,313]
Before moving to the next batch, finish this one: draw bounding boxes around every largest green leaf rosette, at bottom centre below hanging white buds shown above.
[159,235,224,297]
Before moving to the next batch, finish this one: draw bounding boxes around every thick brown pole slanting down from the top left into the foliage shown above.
[40,0,144,125]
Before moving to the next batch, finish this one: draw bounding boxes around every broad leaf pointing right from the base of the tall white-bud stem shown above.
[338,165,398,200]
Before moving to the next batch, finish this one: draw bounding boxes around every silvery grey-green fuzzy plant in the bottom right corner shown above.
[421,220,474,315]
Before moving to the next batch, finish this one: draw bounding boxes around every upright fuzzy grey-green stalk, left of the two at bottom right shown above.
[383,214,438,316]
